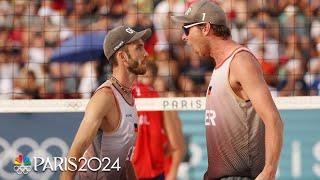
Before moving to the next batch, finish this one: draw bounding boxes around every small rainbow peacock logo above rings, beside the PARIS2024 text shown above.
[13,154,32,174]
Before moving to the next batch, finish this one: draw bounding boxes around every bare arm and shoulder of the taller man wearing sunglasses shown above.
[230,52,283,179]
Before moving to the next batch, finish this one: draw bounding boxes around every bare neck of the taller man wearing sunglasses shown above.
[210,39,240,67]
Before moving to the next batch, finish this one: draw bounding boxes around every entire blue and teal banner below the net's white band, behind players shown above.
[0,110,320,180]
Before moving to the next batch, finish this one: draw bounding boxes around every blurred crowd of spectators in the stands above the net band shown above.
[0,0,320,99]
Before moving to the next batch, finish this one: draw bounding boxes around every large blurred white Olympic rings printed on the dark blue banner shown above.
[0,137,69,179]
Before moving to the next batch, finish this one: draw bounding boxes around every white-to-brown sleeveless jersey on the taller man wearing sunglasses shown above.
[205,47,265,179]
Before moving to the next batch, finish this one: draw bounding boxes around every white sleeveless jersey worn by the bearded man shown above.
[76,81,138,180]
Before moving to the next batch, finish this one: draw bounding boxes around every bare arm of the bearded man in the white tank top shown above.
[60,89,114,180]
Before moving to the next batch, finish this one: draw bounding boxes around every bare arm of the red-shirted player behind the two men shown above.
[164,111,186,180]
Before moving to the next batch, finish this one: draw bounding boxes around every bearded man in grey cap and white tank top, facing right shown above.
[61,26,151,180]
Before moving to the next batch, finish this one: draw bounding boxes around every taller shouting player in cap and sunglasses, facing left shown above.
[172,0,283,180]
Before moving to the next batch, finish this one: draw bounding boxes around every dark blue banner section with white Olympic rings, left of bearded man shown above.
[0,113,83,180]
